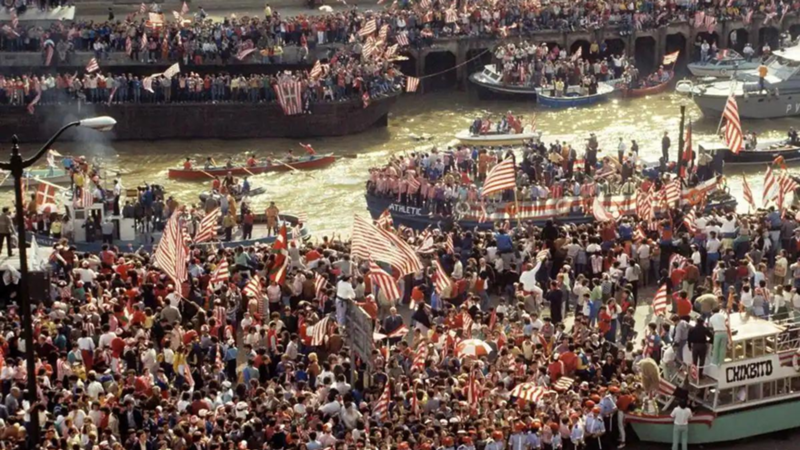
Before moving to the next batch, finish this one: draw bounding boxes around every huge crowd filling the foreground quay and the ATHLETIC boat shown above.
[0,125,800,450]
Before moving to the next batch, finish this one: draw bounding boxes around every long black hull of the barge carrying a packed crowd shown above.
[7,92,401,142]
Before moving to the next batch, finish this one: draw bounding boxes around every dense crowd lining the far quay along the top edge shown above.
[0,0,792,64]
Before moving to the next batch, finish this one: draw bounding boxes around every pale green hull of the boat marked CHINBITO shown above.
[628,401,800,445]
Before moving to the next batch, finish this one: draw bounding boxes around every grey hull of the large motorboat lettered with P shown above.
[692,93,800,119]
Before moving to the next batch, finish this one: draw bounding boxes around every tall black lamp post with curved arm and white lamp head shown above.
[0,116,117,447]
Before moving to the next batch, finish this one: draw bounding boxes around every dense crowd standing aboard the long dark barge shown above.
[0,47,402,105]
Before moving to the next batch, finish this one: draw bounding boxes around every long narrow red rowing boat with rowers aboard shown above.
[168,153,336,181]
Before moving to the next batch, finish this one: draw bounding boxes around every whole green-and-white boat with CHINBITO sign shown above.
[625,313,800,445]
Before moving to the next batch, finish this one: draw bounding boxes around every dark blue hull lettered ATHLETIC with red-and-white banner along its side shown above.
[366,178,736,230]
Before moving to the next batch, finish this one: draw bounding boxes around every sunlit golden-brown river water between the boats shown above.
[7,91,797,237]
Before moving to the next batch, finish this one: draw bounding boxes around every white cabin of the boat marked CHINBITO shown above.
[686,313,800,413]
